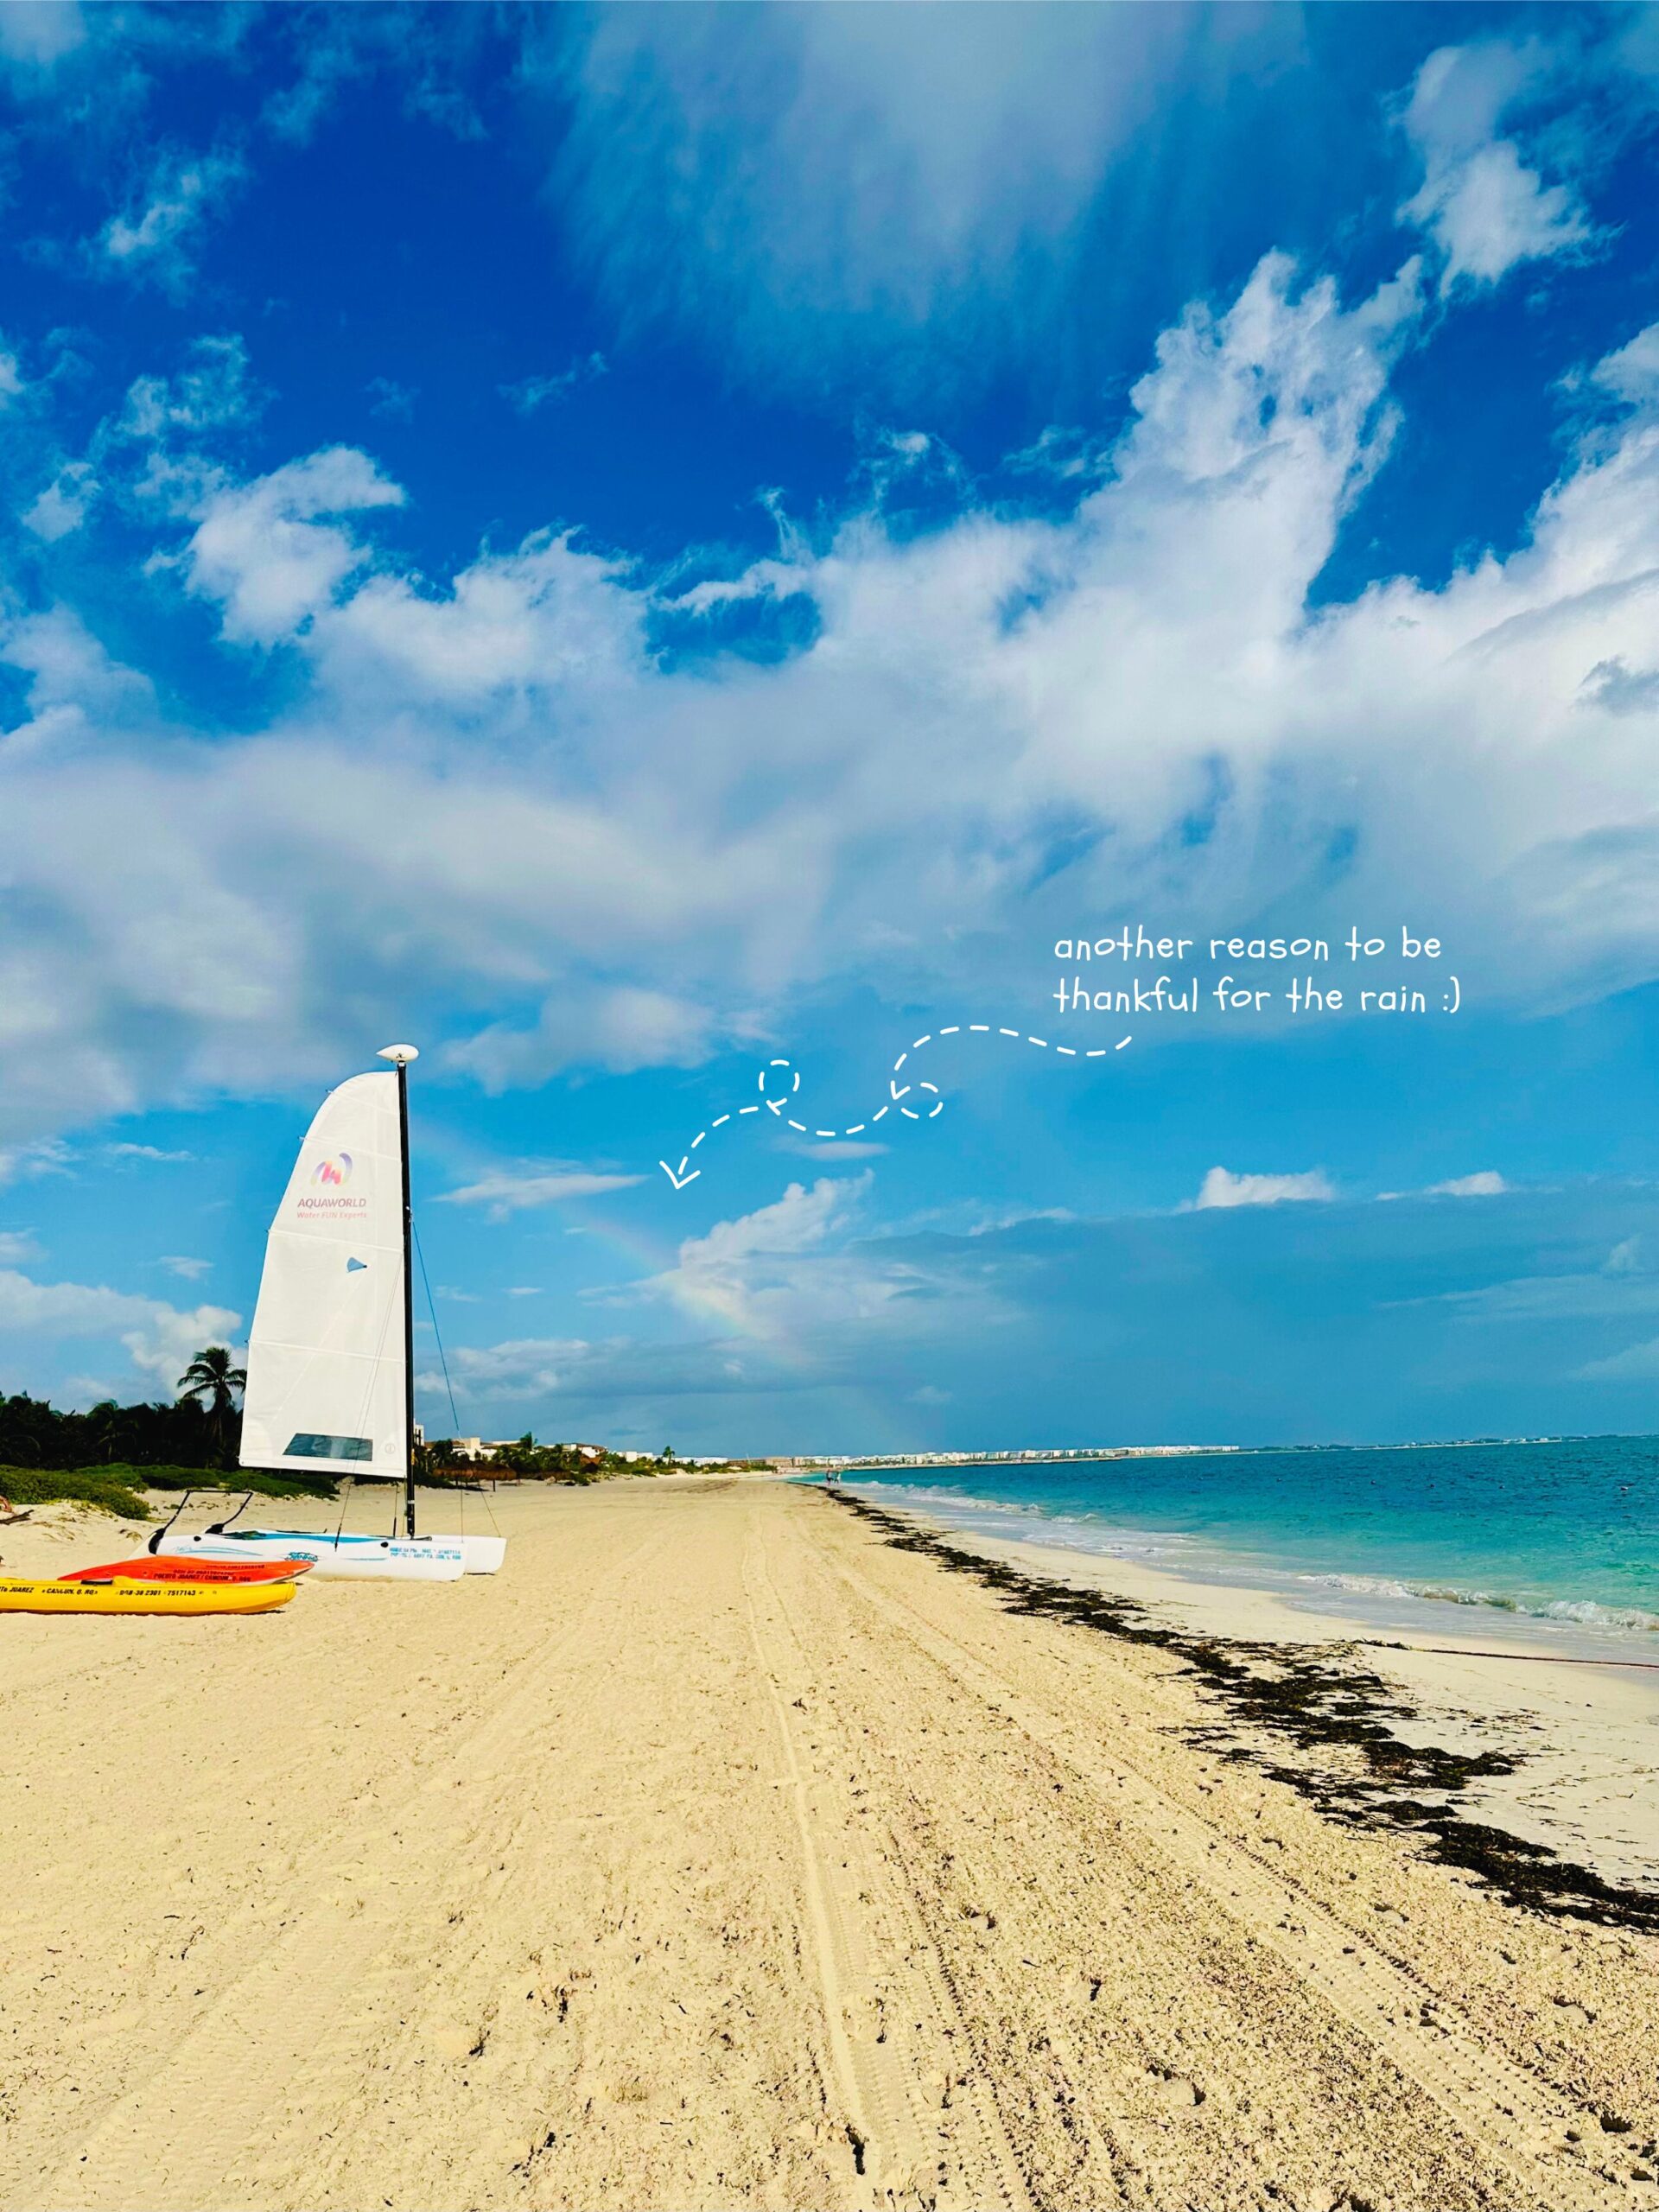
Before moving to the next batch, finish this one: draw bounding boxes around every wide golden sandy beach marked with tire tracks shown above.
[0,1480,1659,2212]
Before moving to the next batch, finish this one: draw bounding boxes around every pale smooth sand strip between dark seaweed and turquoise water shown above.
[845,1489,1659,1924]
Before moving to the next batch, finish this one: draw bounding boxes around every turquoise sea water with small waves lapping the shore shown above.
[847,1435,1659,1656]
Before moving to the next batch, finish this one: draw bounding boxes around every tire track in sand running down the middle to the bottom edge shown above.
[743,1526,1031,2212]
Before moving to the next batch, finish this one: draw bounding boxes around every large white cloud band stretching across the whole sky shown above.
[13,257,1659,1146]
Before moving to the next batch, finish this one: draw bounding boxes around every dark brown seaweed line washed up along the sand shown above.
[821,1491,1659,1933]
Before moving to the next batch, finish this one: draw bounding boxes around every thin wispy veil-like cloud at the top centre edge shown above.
[539,7,1299,391]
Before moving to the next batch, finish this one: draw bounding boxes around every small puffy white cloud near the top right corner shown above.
[1400,40,1591,289]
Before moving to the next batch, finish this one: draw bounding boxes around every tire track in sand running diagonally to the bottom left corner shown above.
[29,1529,672,2212]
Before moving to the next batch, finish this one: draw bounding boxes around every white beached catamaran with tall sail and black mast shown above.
[150,1044,506,1581]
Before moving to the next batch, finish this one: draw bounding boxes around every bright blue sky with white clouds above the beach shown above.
[0,0,1659,1453]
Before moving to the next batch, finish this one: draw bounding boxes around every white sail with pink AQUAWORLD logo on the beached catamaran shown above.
[241,1068,410,1482]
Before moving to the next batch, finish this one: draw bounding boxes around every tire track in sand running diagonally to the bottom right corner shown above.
[832,1513,1655,2212]
